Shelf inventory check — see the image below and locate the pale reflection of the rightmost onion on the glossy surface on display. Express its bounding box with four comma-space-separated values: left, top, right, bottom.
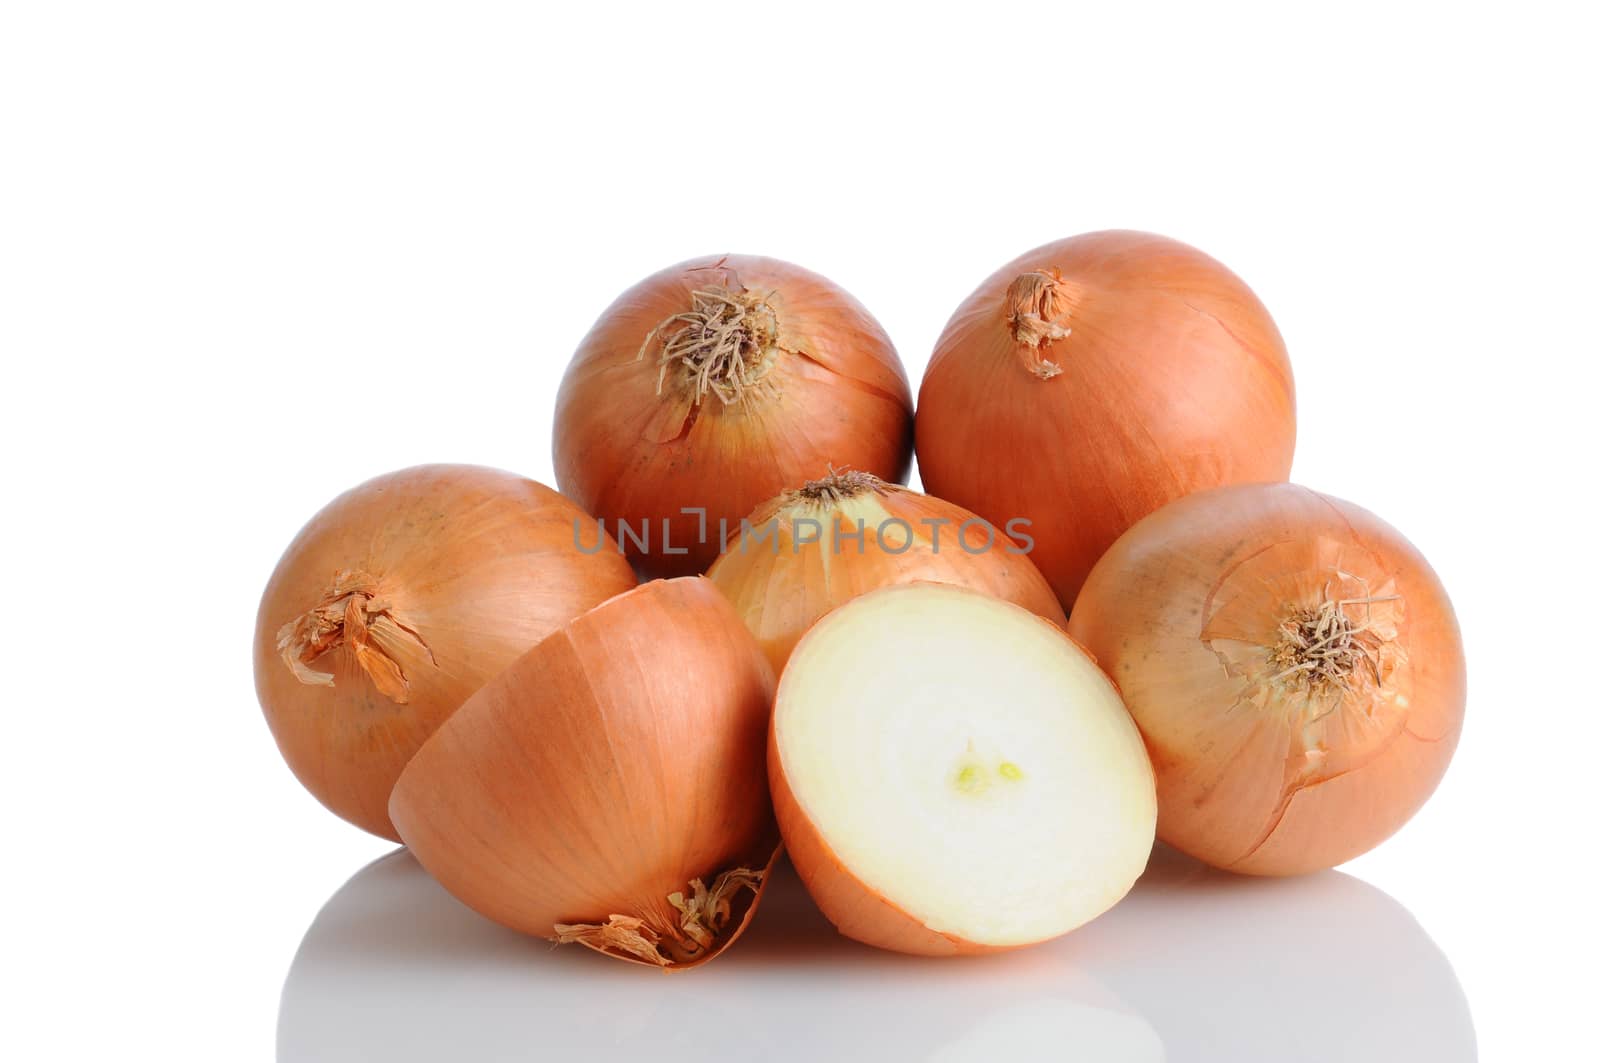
1070, 845, 1477, 1063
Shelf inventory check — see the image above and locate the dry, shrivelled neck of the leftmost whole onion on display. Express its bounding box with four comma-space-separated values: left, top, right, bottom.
278, 570, 432, 704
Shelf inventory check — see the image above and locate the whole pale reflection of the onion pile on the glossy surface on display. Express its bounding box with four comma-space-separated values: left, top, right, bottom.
278, 848, 1477, 1063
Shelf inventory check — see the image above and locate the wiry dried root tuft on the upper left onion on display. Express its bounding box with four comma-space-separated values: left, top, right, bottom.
637, 288, 781, 405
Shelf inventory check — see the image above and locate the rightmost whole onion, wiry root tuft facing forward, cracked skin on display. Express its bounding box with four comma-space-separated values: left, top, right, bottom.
1067, 483, 1466, 874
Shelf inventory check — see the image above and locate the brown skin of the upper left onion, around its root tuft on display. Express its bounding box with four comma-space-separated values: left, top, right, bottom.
554, 255, 912, 576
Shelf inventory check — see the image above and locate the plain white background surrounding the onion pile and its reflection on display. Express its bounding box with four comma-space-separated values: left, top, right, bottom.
0, 2, 1600, 1060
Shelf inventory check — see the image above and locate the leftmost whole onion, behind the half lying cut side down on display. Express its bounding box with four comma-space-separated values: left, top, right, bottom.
254, 464, 635, 840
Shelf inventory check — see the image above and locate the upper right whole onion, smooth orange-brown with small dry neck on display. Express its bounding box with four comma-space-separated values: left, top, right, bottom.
917, 231, 1294, 613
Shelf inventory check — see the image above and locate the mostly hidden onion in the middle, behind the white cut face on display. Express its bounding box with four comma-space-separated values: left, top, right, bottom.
707, 472, 1067, 672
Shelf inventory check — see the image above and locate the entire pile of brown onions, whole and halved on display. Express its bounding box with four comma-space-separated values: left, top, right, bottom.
254, 232, 1466, 970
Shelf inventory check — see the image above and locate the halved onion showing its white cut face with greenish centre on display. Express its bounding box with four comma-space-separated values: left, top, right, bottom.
768, 584, 1155, 956
